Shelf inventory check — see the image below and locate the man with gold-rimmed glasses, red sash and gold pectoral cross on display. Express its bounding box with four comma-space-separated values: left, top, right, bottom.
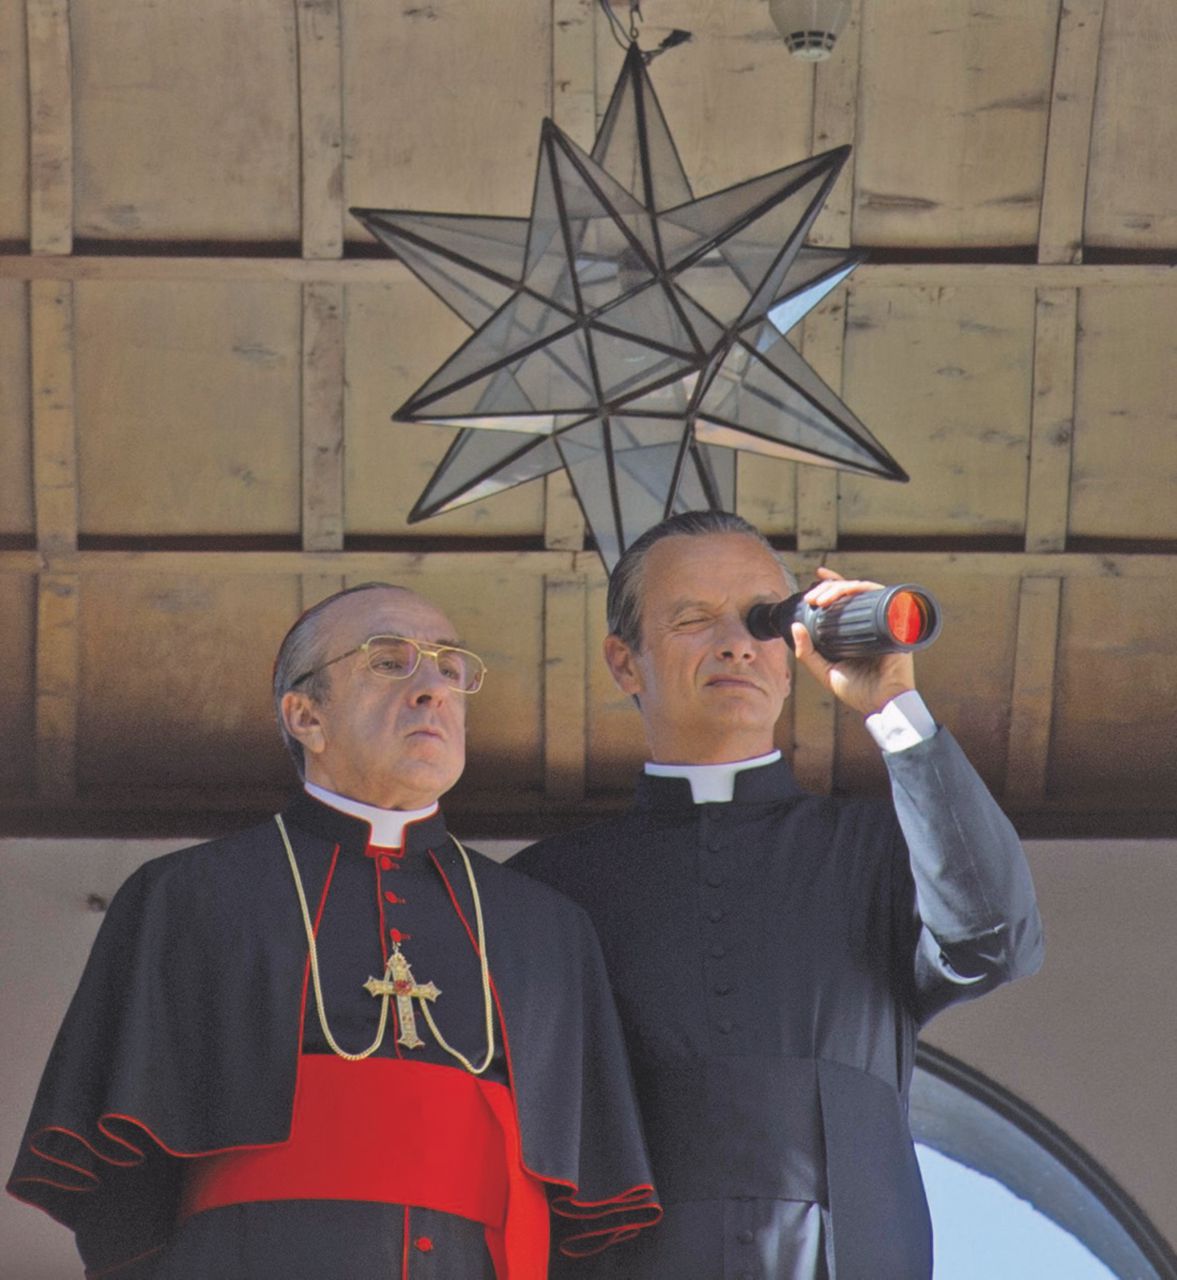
9, 584, 660, 1280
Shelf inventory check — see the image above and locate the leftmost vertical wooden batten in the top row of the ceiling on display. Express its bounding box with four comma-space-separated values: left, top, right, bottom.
24, 0, 73, 253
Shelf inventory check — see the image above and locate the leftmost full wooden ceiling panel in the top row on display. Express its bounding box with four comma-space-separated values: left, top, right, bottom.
70, 0, 299, 244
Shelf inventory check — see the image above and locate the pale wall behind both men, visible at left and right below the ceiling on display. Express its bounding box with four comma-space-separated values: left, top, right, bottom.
0, 840, 1177, 1280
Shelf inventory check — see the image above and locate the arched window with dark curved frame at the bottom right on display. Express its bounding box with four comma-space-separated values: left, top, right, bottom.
911, 1044, 1177, 1280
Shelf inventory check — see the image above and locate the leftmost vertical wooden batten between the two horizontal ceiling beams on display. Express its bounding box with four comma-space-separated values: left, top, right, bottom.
29, 280, 78, 554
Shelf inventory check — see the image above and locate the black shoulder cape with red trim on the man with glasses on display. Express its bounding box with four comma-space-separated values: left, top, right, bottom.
8, 795, 659, 1270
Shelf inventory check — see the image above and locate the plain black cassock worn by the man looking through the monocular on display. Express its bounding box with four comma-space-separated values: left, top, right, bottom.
512, 728, 1043, 1280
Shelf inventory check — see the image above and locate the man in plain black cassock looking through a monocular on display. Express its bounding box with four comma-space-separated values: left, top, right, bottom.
514, 512, 1043, 1280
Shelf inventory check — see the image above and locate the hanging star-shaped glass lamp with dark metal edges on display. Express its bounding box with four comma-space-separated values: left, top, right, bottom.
352, 42, 907, 568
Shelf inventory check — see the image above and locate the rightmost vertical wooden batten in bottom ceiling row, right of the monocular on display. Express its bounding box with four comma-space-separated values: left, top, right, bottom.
1004, 577, 1062, 808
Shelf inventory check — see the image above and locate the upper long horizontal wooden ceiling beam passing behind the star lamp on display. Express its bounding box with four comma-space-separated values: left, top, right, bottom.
0, 251, 1177, 289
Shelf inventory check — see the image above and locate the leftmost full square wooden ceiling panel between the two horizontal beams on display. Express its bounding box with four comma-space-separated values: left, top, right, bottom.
74, 280, 302, 536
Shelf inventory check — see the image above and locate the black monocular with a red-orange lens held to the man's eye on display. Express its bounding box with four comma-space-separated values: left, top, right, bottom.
745, 584, 940, 662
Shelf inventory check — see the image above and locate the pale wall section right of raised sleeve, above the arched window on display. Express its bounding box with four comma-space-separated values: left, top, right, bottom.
925, 840, 1177, 1245
